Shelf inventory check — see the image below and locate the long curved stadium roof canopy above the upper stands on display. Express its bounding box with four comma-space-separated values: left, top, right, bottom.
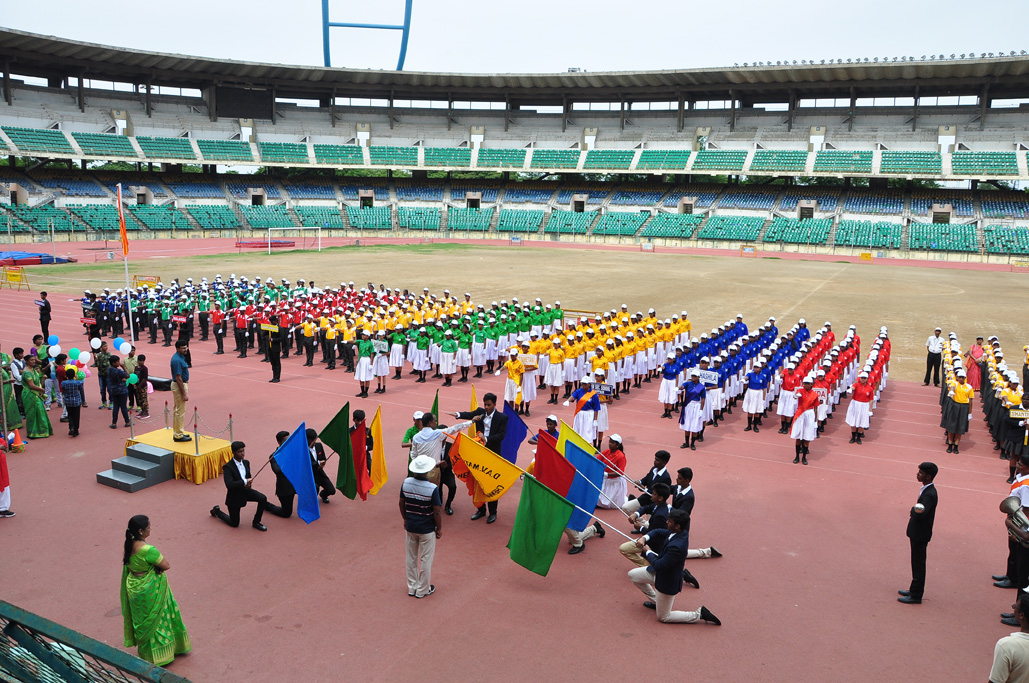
0, 28, 1029, 105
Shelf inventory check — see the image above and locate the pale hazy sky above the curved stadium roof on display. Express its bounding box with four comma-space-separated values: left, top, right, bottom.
0, 0, 1029, 73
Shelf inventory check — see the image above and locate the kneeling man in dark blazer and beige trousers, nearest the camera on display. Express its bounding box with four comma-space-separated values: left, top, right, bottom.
629, 510, 721, 625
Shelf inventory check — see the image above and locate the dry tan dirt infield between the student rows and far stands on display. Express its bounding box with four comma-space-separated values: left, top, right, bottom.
22, 244, 1029, 381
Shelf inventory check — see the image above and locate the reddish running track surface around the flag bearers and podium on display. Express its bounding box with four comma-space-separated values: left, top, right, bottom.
0, 291, 1013, 683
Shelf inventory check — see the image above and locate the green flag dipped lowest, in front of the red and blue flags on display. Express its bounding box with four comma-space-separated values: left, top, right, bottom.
507, 474, 575, 576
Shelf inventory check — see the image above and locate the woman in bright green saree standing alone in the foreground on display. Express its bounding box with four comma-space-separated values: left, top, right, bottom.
121, 514, 192, 667
